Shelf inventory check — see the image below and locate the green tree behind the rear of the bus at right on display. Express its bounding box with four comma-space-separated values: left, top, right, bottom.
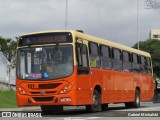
133, 39, 160, 76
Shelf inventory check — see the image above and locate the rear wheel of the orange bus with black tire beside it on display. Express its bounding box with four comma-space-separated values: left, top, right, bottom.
125, 89, 140, 108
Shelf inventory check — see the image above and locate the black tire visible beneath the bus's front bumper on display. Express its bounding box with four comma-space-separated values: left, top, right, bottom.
41, 105, 63, 114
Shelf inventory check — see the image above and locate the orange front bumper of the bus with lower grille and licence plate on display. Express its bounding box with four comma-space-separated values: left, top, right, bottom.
16, 91, 76, 106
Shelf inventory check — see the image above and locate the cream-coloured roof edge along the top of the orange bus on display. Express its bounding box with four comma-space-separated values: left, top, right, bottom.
21, 30, 150, 57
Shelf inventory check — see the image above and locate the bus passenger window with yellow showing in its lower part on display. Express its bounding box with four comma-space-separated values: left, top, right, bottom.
89, 42, 100, 68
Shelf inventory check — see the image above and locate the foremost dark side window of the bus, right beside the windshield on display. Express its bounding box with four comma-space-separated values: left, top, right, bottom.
76, 43, 89, 74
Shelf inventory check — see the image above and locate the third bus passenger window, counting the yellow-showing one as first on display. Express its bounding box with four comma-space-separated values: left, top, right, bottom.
112, 48, 122, 71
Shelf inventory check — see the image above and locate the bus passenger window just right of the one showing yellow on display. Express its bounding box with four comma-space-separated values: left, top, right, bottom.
100, 45, 112, 69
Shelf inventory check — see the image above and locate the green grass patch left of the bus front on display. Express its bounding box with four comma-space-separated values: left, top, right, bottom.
0, 90, 17, 108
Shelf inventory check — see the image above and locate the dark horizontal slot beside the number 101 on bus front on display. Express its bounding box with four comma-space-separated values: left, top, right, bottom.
39, 83, 62, 89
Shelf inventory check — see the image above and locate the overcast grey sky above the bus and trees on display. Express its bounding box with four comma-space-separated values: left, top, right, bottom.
0, 0, 160, 46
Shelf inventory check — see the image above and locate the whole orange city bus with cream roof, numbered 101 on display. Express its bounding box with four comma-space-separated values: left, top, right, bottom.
16, 30, 154, 112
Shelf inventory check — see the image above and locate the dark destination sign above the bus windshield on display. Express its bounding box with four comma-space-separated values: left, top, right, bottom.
18, 32, 72, 46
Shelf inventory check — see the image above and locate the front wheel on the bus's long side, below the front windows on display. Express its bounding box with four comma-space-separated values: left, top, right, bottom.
86, 90, 102, 112
